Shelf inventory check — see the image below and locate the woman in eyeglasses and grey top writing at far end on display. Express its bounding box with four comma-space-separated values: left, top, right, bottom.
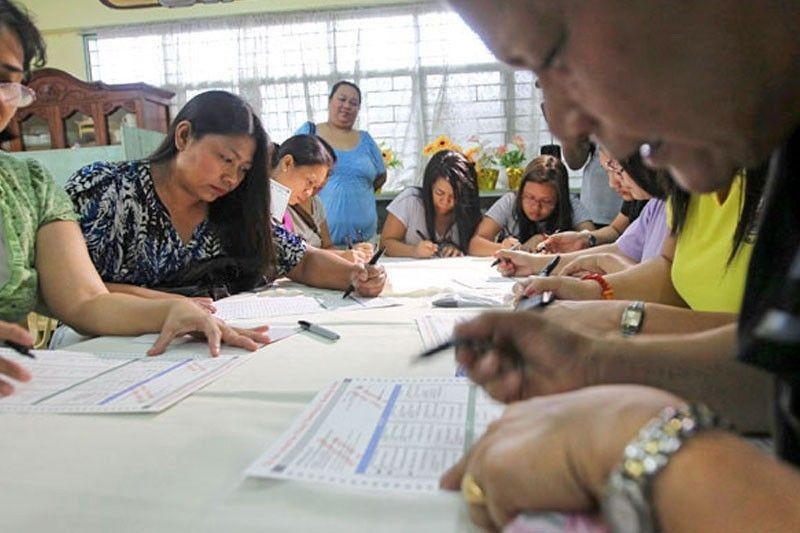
469, 155, 594, 256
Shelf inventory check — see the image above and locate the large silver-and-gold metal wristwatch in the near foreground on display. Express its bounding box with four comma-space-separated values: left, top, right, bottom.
601, 404, 722, 533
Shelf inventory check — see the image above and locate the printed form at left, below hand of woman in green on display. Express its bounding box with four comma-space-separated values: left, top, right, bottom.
0, 349, 246, 413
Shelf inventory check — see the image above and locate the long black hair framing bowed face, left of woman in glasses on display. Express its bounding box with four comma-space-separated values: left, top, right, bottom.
422, 150, 481, 253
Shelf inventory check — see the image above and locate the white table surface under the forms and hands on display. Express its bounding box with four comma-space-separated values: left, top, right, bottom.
0, 258, 516, 532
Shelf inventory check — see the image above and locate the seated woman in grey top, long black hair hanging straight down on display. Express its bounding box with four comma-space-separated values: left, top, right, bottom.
381, 150, 481, 259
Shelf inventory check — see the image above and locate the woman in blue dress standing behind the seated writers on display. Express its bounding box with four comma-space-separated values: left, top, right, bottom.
296, 81, 386, 246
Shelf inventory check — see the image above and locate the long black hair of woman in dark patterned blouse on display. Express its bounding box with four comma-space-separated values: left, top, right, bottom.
148, 91, 275, 272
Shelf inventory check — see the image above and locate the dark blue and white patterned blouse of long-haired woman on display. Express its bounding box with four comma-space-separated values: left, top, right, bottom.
65, 161, 306, 287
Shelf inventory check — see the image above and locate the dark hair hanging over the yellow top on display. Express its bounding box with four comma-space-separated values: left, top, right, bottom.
669, 162, 769, 265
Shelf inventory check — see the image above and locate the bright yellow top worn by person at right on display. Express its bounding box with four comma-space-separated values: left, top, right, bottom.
667, 174, 753, 313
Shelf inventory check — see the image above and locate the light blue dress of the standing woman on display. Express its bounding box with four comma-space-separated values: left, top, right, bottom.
295, 122, 386, 245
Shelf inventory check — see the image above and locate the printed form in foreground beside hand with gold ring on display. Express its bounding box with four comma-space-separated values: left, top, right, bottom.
247, 378, 504, 492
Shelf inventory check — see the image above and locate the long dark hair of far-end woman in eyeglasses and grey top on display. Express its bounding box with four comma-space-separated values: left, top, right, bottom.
514, 155, 573, 237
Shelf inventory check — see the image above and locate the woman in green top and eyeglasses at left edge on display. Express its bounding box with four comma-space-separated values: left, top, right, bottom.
0, 0, 269, 396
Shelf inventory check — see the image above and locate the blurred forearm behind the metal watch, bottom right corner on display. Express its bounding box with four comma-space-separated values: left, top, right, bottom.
652, 431, 800, 533
